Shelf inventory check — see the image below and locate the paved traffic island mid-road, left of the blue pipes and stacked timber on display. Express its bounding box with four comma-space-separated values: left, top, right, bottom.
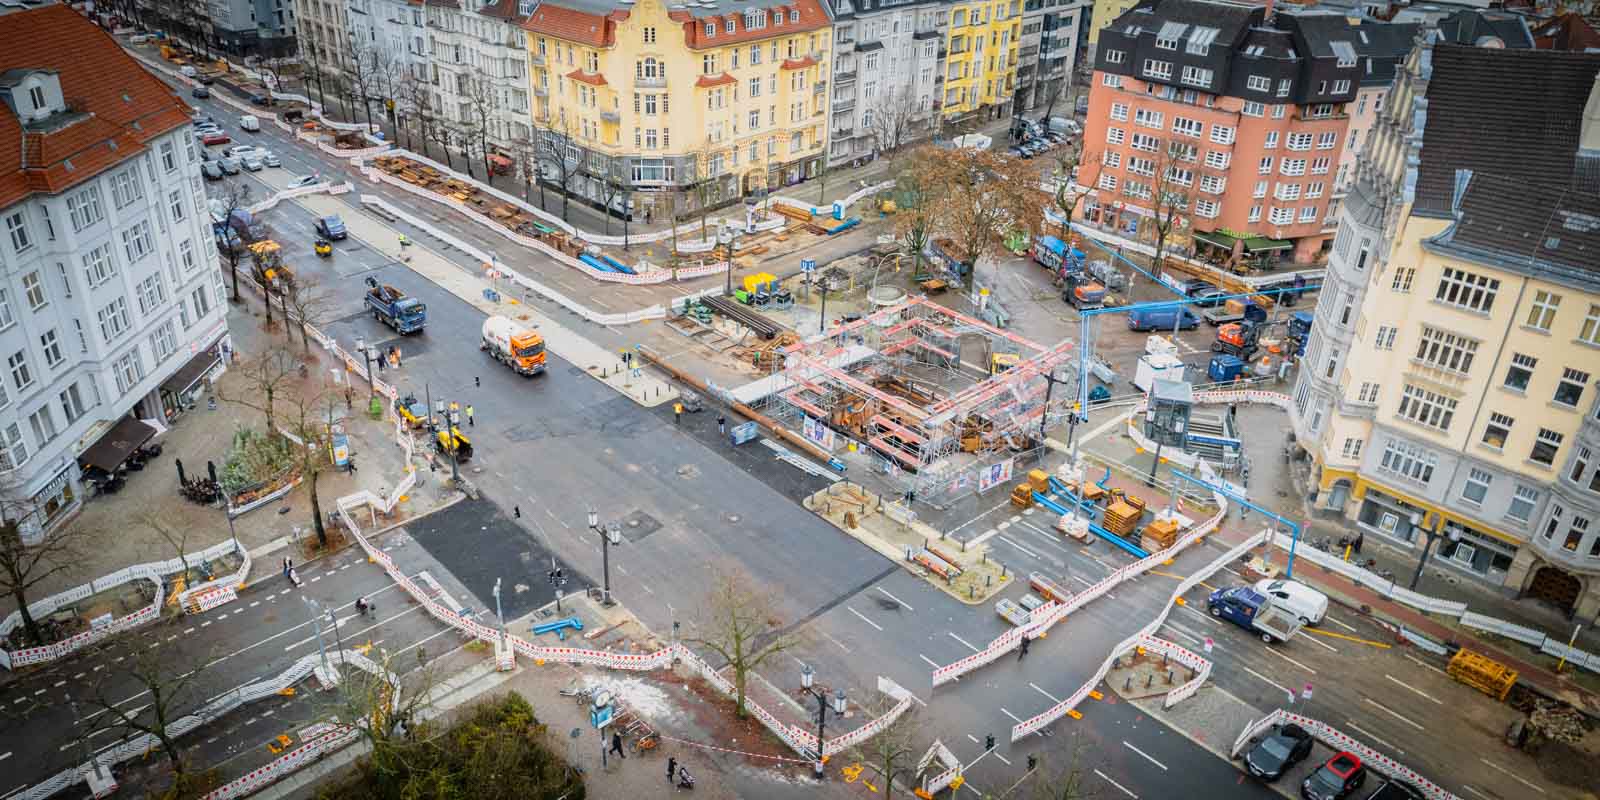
802, 482, 1014, 605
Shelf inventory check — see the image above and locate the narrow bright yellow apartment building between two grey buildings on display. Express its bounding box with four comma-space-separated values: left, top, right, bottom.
941, 0, 1022, 122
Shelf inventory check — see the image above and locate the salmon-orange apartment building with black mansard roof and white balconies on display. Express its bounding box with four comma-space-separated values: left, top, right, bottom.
1078, 0, 1414, 264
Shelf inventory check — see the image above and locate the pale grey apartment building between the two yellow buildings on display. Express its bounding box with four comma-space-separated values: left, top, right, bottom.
827, 0, 950, 165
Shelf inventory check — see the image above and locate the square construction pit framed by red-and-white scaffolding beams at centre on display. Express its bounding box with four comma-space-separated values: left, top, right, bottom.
731, 298, 1077, 506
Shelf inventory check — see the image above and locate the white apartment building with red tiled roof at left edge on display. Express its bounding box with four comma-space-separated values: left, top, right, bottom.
0, 5, 227, 541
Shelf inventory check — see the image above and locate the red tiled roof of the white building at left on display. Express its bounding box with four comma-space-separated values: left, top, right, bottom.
0, 5, 189, 206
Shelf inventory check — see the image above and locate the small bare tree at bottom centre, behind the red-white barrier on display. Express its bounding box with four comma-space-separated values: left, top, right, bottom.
683, 565, 797, 717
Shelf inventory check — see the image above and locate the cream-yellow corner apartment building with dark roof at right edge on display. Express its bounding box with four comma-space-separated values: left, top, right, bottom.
1293, 39, 1600, 619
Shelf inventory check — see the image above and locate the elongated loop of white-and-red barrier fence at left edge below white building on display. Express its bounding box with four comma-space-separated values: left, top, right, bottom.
0, 539, 250, 669
